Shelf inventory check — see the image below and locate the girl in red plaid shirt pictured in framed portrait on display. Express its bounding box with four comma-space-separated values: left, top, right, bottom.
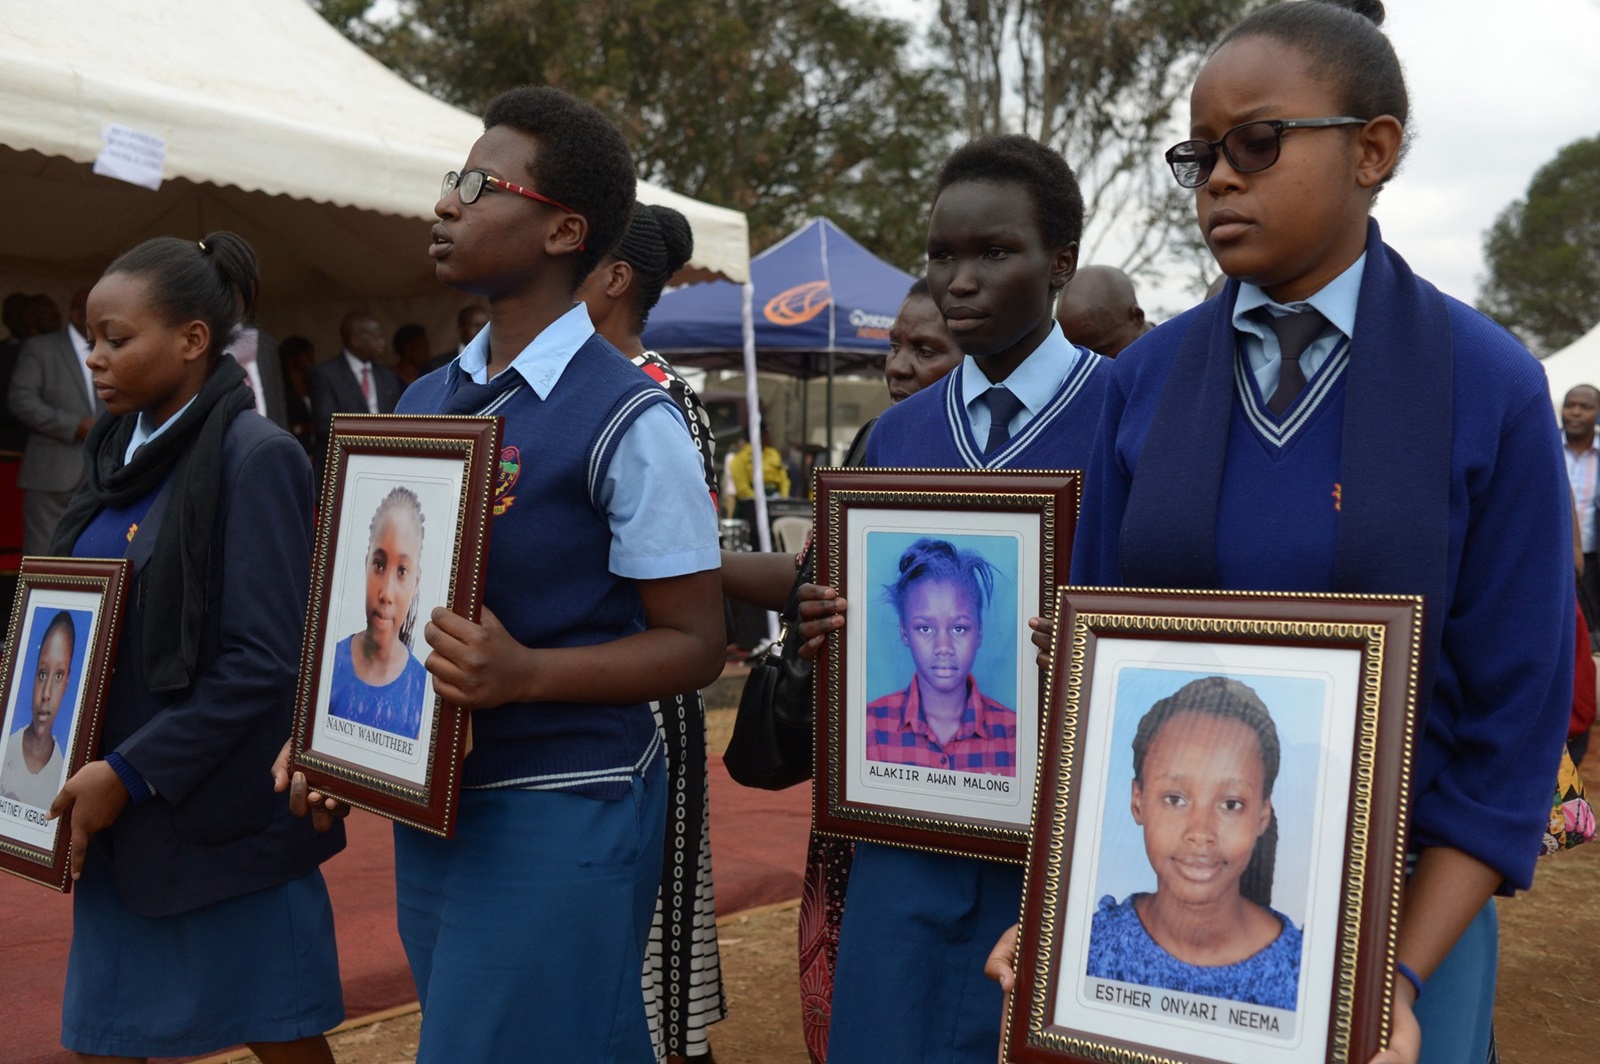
866, 536, 1016, 776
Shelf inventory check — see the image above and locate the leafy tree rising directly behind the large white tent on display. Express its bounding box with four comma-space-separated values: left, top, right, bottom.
312, 0, 957, 267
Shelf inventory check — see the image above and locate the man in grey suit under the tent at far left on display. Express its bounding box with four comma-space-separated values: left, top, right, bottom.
6, 288, 106, 554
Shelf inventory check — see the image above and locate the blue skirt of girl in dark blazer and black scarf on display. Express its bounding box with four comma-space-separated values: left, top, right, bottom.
61, 867, 344, 1056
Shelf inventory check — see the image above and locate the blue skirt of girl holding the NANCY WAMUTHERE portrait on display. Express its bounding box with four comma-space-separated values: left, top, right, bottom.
395, 760, 667, 1064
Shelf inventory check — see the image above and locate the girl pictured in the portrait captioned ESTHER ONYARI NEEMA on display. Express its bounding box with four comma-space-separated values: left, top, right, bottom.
1088, 677, 1301, 1010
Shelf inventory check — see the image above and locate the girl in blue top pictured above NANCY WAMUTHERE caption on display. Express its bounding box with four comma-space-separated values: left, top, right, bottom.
328, 488, 427, 739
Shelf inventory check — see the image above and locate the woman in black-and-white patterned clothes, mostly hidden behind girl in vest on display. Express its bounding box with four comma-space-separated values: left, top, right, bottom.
578, 203, 728, 1064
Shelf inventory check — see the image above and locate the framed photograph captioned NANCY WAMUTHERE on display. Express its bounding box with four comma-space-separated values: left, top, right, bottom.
291, 414, 509, 837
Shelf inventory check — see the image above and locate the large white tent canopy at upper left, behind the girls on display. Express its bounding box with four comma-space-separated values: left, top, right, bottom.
0, 0, 749, 354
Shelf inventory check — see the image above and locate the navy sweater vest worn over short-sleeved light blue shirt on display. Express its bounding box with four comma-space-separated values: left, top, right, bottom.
395, 336, 672, 800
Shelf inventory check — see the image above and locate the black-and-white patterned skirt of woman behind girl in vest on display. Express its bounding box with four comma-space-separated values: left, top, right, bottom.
643, 691, 728, 1061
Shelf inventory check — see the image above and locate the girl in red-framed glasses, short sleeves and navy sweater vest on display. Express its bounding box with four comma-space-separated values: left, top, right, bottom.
385, 88, 723, 1064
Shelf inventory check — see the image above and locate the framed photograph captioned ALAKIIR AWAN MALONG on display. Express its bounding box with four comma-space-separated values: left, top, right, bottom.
813, 469, 1082, 862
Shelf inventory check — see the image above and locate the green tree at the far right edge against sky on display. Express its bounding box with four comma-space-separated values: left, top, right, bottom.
1478, 136, 1600, 355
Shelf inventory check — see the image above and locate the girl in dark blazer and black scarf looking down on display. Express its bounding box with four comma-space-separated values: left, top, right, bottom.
51, 232, 344, 1064
